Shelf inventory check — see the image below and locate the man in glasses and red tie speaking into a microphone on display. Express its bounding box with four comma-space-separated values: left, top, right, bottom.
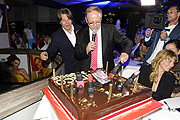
75, 6, 133, 71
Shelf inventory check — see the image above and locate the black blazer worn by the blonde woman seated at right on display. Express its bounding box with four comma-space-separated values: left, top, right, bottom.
138, 65, 176, 100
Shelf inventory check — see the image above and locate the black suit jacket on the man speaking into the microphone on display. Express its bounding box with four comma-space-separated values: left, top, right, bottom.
75, 24, 133, 71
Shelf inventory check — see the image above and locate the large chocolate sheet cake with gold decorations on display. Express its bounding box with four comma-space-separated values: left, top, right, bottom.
49, 72, 152, 120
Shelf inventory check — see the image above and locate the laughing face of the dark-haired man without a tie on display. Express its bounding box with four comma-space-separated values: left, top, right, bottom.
59, 14, 72, 31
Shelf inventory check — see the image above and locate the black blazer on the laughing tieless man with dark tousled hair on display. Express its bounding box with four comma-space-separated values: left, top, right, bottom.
46, 25, 81, 74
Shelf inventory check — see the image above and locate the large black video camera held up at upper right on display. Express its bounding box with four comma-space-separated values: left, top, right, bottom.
145, 13, 166, 30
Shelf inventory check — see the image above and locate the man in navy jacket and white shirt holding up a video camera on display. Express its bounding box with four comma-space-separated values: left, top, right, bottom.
143, 6, 180, 65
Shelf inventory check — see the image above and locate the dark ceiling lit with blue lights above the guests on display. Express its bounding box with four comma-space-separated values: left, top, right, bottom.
6, 0, 180, 12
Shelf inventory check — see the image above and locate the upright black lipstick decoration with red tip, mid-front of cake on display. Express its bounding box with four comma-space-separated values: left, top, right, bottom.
88, 75, 94, 98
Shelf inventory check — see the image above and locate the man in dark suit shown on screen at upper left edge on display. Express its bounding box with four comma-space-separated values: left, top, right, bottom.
0, 5, 7, 32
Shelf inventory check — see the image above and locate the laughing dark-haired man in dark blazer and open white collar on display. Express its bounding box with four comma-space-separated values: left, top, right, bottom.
40, 8, 81, 74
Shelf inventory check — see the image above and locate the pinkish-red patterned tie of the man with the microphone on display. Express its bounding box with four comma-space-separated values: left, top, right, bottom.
91, 34, 98, 70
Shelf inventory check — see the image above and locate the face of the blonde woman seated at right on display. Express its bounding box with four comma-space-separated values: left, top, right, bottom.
159, 57, 175, 72
